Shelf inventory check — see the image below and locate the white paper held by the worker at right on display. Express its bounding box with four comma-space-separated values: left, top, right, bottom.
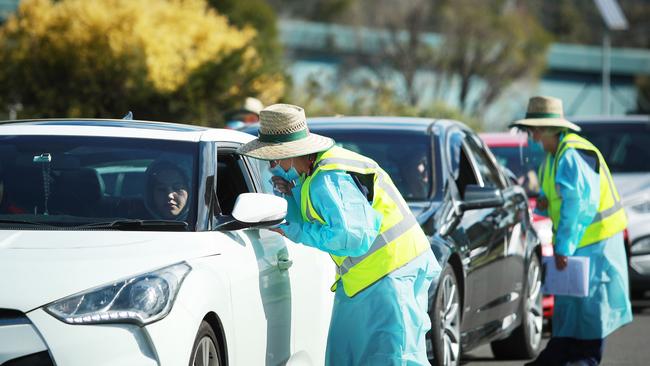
542, 257, 589, 297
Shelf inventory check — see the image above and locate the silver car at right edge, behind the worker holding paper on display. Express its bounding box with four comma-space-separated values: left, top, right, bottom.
570, 116, 650, 297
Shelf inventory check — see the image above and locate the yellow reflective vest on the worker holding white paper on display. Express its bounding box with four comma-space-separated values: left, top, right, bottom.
539, 133, 627, 248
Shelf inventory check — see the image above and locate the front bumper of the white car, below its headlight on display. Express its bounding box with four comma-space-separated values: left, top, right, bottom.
0, 304, 200, 366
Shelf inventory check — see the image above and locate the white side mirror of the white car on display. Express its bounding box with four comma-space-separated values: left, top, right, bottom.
232, 193, 287, 227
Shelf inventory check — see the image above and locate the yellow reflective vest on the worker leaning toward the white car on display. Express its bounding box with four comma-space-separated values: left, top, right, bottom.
300, 147, 430, 297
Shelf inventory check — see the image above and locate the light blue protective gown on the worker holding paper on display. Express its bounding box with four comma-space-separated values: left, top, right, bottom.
542, 148, 632, 339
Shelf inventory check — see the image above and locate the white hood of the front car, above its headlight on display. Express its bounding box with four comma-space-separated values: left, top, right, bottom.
0, 230, 220, 312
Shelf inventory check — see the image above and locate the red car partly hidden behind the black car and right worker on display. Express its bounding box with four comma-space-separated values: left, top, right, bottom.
479, 132, 554, 324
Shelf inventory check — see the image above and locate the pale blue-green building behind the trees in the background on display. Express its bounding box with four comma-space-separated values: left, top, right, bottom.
279, 19, 650, 130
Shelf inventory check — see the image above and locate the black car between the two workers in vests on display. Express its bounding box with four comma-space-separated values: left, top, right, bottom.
243, 117, 542, 365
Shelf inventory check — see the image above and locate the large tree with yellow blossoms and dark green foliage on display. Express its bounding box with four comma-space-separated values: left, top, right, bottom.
0, 0, 284, 125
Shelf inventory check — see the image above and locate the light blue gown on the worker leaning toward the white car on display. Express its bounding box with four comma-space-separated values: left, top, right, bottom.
281, 170, 440, 366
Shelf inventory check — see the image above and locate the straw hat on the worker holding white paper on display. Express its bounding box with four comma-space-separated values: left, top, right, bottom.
510, 96, 580, 131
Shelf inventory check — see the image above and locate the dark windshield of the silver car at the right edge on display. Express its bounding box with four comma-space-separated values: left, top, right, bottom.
580, 122, 650, 173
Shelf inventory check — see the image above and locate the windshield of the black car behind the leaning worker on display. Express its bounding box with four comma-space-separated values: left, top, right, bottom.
311, 127, 433, 201
